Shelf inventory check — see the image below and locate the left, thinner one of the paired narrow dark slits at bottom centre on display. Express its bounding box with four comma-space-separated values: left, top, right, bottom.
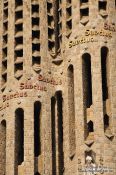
51, 97, 56, 175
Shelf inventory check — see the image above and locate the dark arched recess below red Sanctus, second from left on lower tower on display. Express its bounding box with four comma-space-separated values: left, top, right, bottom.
15, 108, 24, 165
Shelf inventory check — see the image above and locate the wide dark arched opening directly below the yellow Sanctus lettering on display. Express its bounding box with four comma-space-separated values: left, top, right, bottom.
82, 53, 92, 108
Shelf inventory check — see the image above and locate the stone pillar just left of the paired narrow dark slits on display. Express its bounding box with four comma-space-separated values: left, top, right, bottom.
42, 96, 52, 175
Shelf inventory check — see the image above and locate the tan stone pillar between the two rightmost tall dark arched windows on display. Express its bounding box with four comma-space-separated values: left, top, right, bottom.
91, 45, 104, 163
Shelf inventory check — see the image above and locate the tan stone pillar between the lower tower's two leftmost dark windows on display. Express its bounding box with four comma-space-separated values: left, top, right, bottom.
6, 110, 16, 175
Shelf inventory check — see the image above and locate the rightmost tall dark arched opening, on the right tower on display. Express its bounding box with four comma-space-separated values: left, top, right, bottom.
101, 47, 108, 101
